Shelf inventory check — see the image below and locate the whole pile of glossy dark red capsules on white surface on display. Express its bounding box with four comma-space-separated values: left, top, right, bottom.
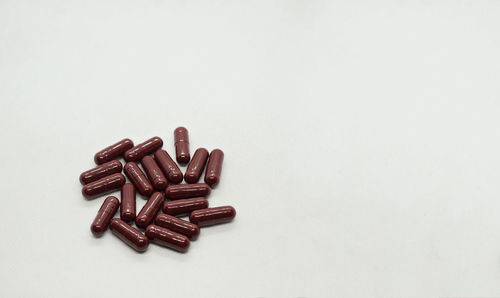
80, 127, 236, 252
